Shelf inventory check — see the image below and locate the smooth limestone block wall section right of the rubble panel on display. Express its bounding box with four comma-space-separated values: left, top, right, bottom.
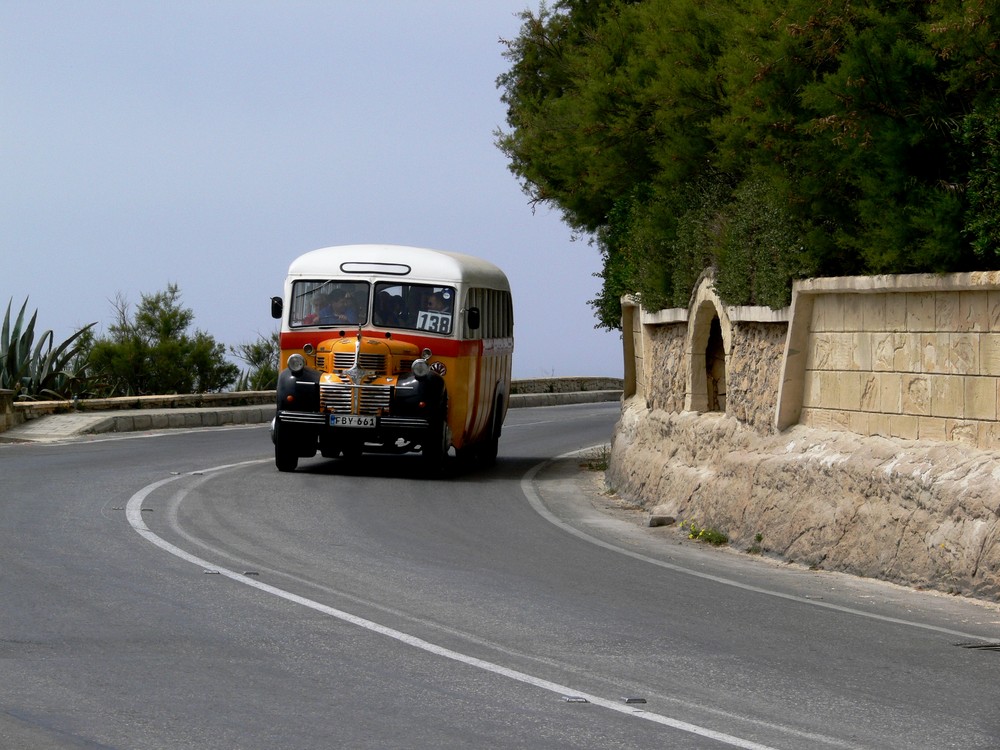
777, 273, 1000, 450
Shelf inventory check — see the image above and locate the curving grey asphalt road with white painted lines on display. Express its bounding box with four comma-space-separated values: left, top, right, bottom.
0, 404, 1000, 750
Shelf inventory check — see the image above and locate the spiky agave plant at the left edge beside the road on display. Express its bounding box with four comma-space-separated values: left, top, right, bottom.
0, 299, 96, 398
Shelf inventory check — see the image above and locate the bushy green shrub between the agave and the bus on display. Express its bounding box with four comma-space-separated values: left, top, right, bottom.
90, 284, 239, 396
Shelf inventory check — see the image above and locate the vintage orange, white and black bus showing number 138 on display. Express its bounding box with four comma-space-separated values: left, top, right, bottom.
271, 245, 514, 471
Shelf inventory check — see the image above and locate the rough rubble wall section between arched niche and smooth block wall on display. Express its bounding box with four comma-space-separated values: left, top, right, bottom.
728, 323, 788, 433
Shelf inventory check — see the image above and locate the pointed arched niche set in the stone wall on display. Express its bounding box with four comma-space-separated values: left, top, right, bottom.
685, 274, 732, 412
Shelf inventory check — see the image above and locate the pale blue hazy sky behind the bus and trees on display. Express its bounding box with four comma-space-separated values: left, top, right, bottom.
0, 0, 622, 378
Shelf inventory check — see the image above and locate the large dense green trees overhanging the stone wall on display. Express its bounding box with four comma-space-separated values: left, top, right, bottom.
497, 0, 1000, 328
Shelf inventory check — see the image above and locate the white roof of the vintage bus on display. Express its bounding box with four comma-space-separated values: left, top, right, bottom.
288, 245, 510, 291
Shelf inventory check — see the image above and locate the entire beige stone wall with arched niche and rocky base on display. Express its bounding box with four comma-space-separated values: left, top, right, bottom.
607, 273, 1000, 598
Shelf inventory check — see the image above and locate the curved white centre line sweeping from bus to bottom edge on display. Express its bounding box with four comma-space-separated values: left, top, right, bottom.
125, 461, 776, 750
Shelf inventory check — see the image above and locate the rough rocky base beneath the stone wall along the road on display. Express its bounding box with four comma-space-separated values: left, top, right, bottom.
607, 399, 1000, 600
